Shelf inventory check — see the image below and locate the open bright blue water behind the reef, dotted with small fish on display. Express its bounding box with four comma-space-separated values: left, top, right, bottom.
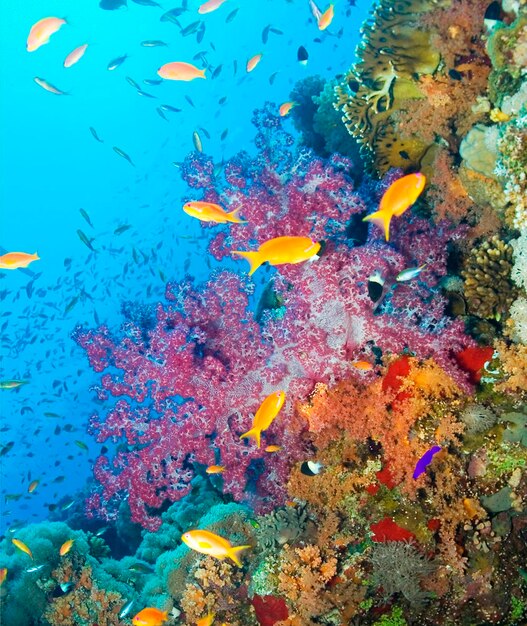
0, 0, 371, 533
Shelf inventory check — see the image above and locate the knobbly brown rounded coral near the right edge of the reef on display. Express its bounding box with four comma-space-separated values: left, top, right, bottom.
461, 235, 516, 321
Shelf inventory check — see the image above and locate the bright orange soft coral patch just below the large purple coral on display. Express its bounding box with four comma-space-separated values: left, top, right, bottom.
295, 359, 461, 490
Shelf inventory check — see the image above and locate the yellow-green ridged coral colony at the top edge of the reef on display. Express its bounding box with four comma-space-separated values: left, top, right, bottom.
335, 0, 449, 174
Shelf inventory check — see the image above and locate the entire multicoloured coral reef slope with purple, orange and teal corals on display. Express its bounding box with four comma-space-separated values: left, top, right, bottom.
4, 0, 527, 626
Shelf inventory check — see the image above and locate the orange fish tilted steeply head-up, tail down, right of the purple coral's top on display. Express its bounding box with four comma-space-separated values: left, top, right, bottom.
363, 172, 426, 241
